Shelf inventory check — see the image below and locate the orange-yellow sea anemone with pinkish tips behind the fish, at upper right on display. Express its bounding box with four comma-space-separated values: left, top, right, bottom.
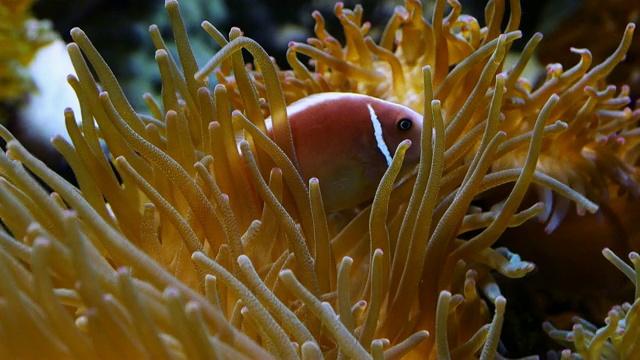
221, 1, 640, 232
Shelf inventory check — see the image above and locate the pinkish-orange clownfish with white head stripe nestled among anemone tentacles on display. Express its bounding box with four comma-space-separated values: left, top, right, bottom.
272, 93, 422, 212
